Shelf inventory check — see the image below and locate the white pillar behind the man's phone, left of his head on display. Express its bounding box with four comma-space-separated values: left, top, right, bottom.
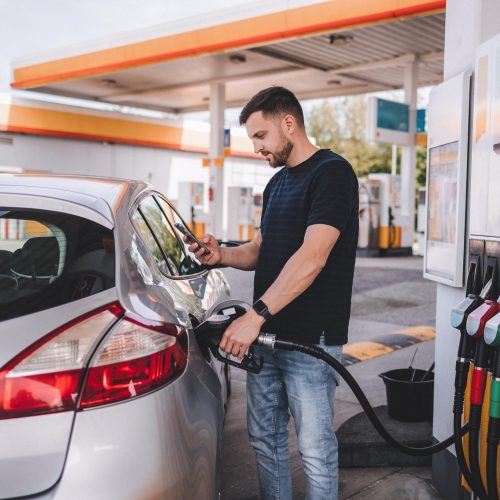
209, 84, 226, 238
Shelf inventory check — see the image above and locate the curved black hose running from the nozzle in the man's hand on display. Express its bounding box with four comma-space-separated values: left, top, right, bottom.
256, 334, 469, 456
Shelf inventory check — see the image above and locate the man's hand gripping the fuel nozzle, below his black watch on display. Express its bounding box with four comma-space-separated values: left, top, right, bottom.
220, 309, 265, 359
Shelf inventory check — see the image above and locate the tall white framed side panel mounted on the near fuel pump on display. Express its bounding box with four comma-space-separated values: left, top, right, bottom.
424, 72, 471, 287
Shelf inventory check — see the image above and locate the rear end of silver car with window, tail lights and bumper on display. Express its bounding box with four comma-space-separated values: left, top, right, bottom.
0, 192, 220, 499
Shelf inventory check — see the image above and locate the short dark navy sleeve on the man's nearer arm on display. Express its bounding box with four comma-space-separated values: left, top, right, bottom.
307, 160, 358, 232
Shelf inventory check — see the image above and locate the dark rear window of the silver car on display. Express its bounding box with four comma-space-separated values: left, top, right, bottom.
0, 207, 115, 321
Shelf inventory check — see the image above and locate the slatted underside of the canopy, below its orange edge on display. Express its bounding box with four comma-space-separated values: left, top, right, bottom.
12, 7, 445, 113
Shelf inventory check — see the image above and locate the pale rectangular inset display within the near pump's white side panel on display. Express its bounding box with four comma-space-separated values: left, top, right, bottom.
426, 141, 459, 280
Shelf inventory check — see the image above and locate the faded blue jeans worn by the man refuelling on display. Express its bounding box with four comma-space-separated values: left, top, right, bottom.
247, 337, 342, 500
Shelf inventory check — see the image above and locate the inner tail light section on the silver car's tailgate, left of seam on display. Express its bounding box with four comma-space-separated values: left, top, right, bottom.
0, 303, 123, 419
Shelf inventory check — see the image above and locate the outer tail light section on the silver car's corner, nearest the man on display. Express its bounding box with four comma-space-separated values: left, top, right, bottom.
80, 317, 187, 408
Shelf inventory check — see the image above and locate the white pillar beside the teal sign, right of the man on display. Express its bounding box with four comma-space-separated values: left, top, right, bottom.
401, 60, 418, 247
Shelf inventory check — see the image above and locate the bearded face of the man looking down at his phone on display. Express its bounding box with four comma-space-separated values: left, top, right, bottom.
245, 111, 293, 168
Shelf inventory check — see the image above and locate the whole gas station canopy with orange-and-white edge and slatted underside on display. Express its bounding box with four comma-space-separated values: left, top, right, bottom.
12, 0, 446, 113
